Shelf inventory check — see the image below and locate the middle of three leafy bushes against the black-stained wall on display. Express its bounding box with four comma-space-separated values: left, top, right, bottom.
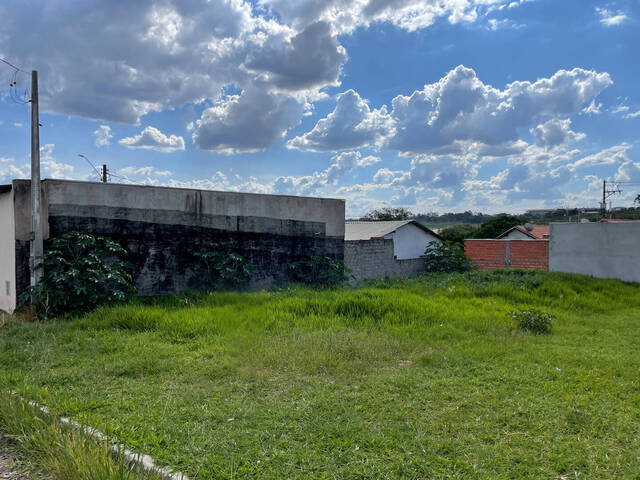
191, 250, 255, 290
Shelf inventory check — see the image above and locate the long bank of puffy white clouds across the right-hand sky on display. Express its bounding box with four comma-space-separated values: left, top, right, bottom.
289, 65, 612, 155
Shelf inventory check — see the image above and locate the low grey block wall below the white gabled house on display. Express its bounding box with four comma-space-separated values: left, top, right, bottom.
344, 239, 424, 280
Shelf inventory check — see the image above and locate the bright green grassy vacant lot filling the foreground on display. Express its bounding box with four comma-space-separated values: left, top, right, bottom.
0, 272, 640, 479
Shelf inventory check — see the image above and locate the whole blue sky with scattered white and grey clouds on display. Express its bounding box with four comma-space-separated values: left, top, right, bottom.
0, 0, 640, 216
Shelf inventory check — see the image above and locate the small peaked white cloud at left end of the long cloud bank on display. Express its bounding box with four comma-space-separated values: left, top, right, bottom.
287, 90, 391, 152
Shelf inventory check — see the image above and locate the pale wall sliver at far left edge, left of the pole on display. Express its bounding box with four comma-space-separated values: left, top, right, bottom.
0, 190, 16, 312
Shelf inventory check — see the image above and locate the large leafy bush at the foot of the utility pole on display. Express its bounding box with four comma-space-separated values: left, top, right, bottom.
20, 232, 134, 319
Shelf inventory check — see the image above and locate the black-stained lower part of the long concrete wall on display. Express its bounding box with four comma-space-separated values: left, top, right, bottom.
45, 205, 344, 295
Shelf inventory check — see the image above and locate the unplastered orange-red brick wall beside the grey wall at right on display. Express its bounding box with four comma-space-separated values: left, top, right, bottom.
464, 240, 549, 270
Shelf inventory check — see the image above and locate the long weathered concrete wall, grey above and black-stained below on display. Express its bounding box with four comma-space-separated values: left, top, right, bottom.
12, 180, 344, 295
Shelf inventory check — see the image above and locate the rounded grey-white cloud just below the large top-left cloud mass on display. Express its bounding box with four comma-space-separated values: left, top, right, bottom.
192, 89, 304, 155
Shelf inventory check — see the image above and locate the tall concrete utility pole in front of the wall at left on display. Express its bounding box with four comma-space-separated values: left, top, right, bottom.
29, 70, 44, 287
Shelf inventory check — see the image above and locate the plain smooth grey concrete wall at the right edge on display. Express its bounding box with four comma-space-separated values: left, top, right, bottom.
549, 222, 640, 282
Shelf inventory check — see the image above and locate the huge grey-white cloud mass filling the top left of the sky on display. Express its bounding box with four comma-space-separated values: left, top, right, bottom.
0, 0, 347, 124
